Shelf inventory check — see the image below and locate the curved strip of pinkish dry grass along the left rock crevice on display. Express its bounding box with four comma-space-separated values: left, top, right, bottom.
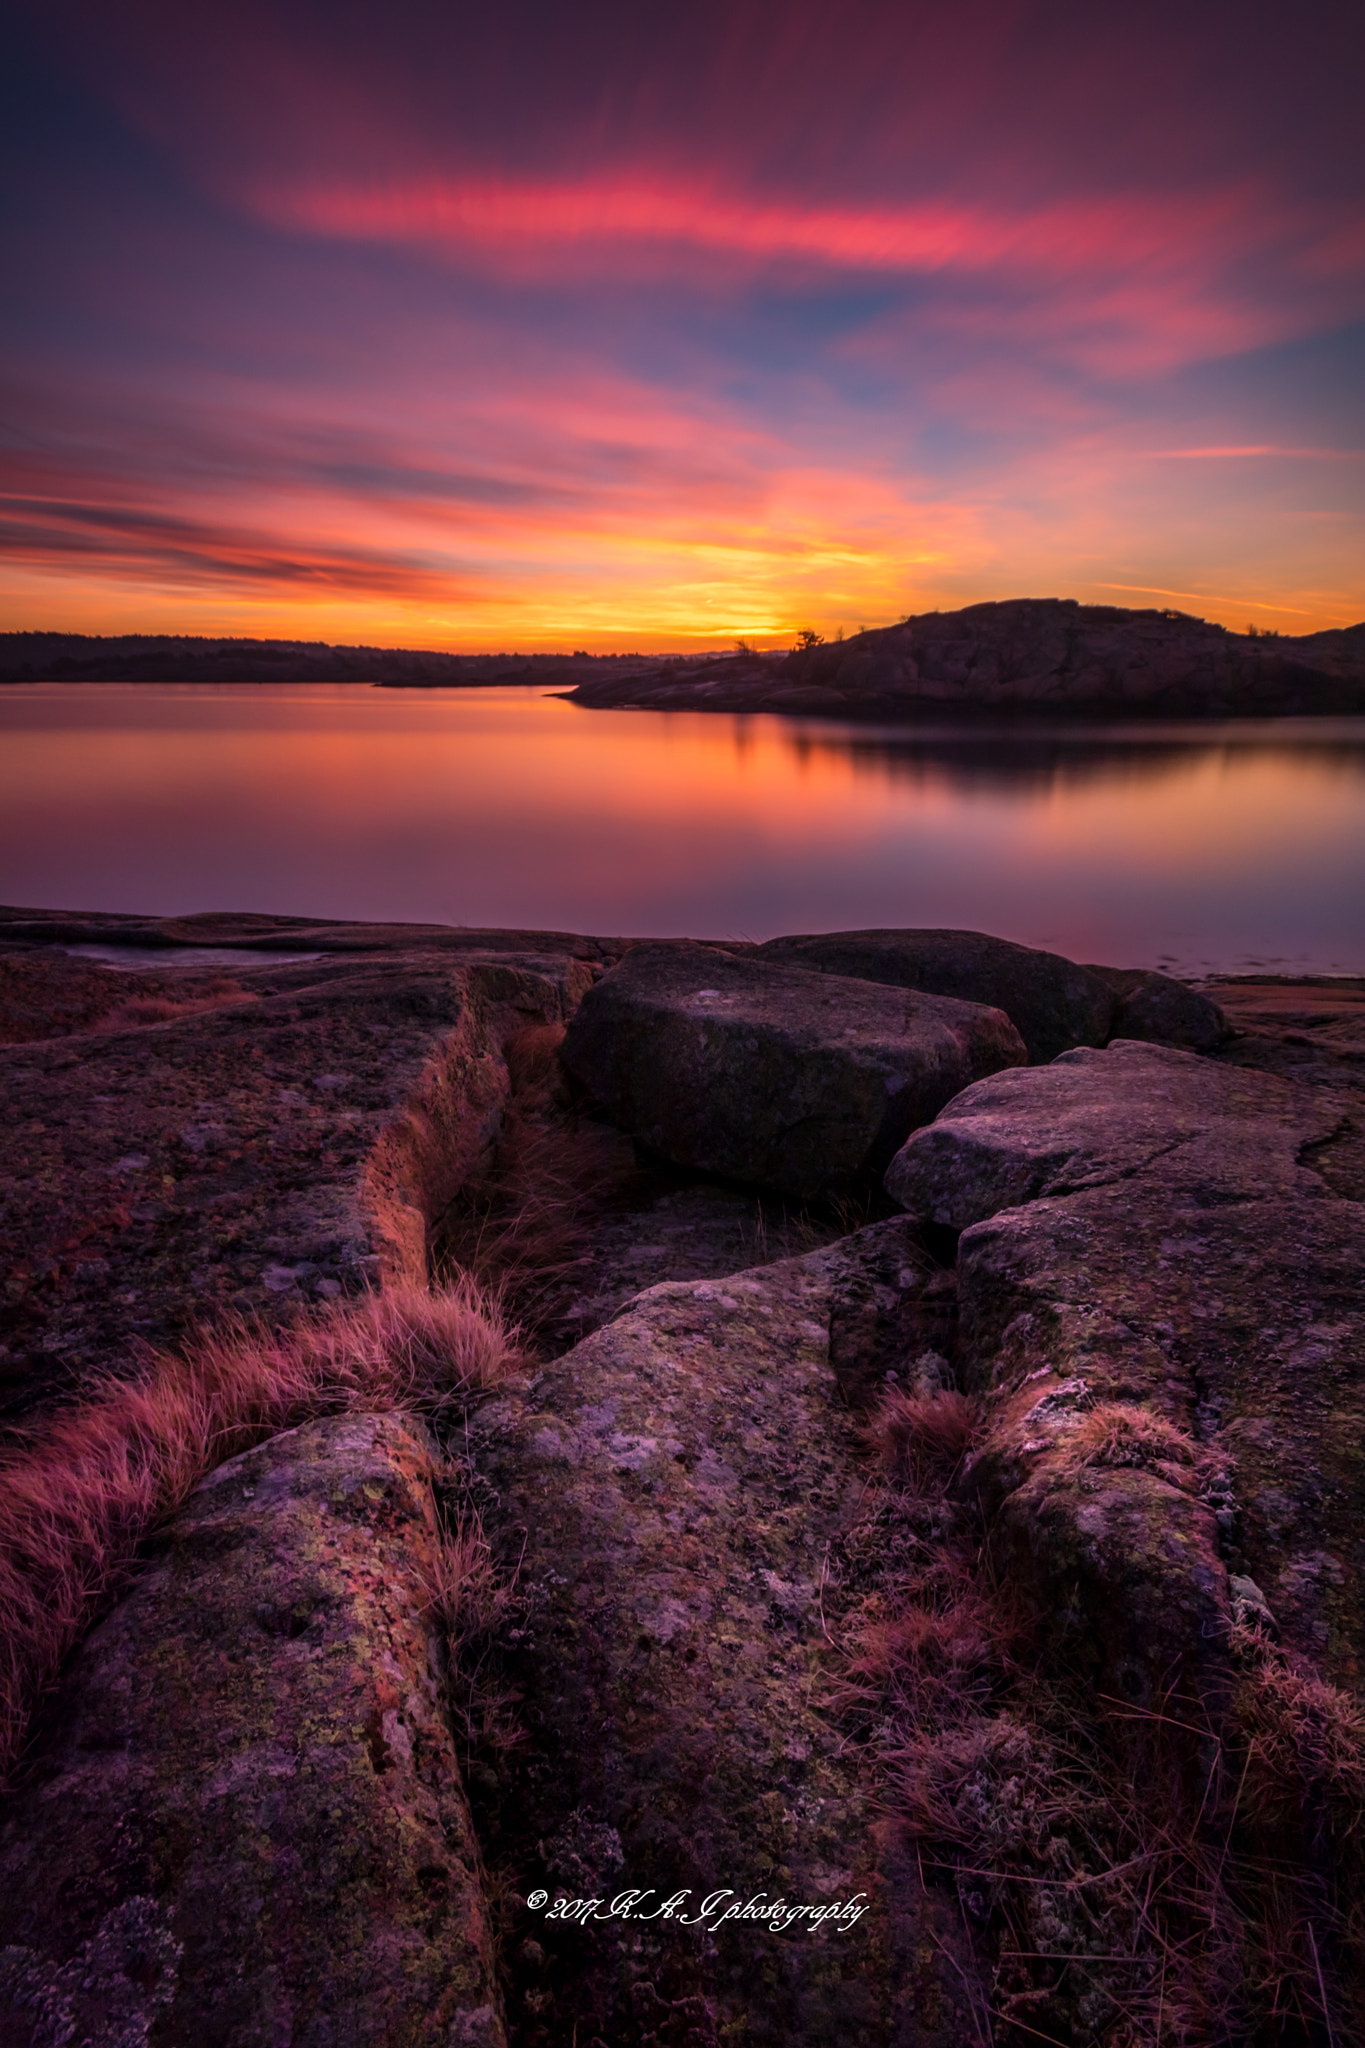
0, 1282, 518, 1772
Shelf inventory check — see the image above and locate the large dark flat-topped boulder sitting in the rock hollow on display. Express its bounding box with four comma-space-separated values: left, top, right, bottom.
563, 942, 1025, 1198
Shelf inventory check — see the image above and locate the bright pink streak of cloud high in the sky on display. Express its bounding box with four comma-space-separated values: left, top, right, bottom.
244, 164, 1365, 377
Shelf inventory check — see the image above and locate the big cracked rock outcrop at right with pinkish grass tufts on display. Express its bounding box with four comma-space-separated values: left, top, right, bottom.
888, 1044, 1365, 1698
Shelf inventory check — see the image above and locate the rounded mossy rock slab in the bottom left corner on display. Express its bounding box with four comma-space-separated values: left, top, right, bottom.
0, 1415, 503, 2048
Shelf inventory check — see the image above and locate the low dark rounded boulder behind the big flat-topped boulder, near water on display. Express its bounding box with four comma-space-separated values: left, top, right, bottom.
757, 930, 1117, 1065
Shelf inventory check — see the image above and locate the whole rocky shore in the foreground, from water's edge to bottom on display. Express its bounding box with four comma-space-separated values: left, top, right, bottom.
0, 911, 1365, 2048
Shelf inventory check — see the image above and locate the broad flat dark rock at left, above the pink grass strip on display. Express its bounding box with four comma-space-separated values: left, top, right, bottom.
0, 915, 593, 1421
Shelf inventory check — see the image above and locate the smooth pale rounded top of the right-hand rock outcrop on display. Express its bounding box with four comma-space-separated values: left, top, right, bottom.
886, 1040, 1338, 1231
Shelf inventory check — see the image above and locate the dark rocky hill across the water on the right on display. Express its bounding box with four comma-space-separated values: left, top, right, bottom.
569, 598, 1365, 719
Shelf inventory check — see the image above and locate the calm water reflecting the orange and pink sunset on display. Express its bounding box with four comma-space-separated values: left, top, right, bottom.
0, 684, 1365, 973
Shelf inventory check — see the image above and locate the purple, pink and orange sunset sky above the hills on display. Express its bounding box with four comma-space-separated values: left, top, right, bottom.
0, 0, 1365, 651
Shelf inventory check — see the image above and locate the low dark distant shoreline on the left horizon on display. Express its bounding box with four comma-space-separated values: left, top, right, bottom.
0, 633, 657, 688
